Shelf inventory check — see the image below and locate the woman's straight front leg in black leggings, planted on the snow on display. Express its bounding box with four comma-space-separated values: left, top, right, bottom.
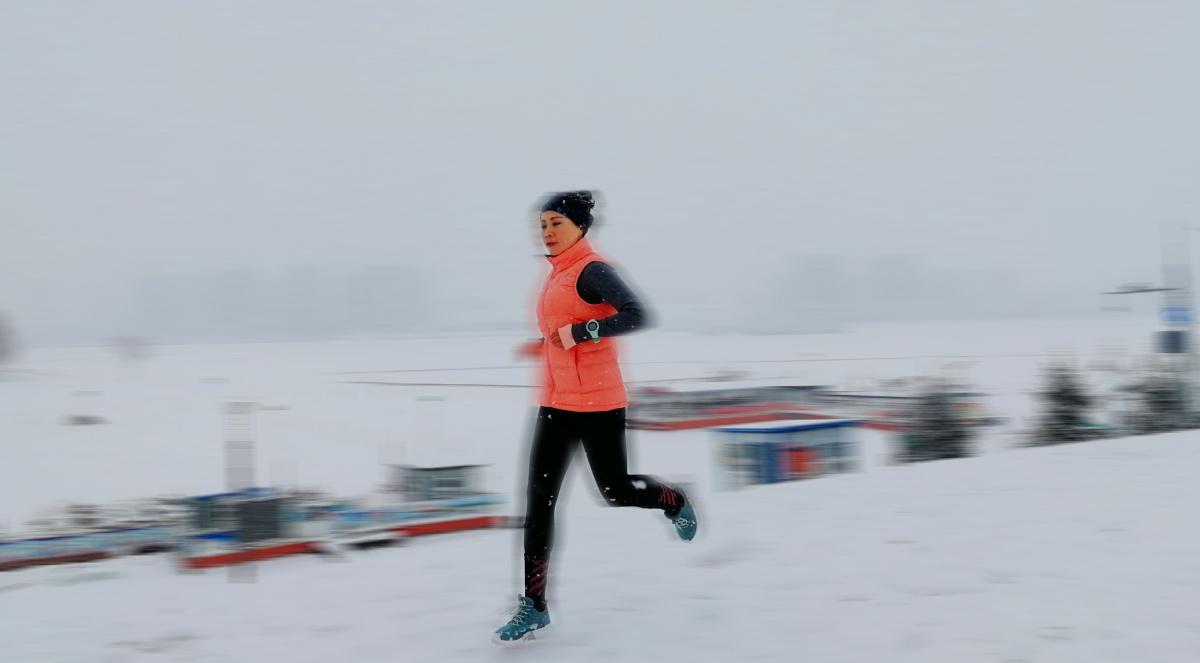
524, 407, 578, 610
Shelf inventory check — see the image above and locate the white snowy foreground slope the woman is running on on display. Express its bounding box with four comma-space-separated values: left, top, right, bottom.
7, 434, 1200, 662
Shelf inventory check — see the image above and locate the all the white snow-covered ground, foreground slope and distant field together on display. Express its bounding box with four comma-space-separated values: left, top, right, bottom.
0, 318, 1200, 663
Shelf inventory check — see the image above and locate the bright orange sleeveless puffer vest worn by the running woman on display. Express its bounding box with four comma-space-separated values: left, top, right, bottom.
538, 239, 628, 412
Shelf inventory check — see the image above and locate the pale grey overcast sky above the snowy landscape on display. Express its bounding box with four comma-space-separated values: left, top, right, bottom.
0, 0, 1200, 340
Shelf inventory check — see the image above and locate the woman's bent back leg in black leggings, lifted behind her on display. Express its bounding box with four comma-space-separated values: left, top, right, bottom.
581, 408, 684, 516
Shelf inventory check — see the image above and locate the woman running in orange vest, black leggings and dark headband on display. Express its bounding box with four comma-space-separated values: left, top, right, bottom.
493, 191, 696, 644
